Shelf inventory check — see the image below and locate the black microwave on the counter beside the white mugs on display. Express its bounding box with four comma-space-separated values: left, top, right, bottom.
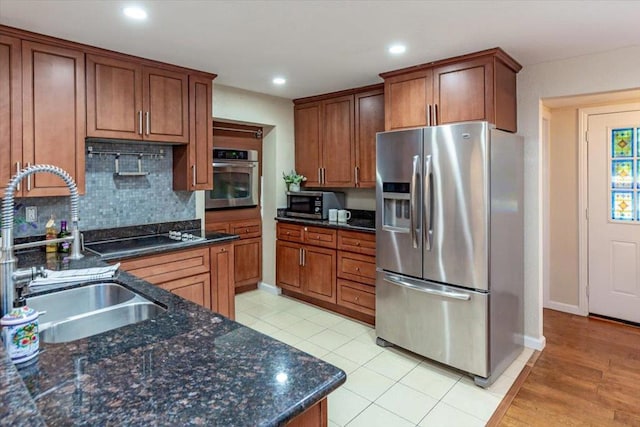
285, 191, 344, 219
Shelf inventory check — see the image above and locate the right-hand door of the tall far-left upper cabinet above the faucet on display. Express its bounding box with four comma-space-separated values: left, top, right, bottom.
16, 40, 86, 197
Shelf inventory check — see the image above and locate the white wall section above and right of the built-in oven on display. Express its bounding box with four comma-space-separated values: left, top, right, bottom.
210, 81, 295, 285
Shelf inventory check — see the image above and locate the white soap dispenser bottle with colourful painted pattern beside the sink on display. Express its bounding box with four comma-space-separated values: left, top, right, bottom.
0, 287, 40, 364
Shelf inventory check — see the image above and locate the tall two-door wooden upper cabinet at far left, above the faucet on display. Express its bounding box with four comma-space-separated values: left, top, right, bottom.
0, 34, 85, 197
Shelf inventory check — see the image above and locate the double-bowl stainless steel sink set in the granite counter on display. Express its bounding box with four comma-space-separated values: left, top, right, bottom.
27, 282, 166, 343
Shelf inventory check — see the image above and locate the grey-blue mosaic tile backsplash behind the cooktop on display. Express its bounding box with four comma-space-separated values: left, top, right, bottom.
3, 141, 196, 237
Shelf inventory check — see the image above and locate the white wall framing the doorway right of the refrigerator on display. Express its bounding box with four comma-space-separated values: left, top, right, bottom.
518, 46, 640, 348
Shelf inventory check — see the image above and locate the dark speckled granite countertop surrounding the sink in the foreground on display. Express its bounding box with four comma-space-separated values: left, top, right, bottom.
0, 232, 346, 426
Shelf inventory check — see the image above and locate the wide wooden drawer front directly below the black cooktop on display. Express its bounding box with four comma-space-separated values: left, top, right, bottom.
120, 248, 209, 285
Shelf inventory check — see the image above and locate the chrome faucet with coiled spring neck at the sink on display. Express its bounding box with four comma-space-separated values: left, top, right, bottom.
0, 165, 83, 316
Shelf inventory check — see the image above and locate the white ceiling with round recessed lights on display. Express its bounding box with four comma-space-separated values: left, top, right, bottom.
0, 0, 640, 98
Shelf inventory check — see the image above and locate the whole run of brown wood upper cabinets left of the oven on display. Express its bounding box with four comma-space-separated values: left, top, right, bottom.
0, 25, 216, 201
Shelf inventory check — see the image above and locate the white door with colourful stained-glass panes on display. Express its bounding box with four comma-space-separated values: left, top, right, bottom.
588, 111, 640, 323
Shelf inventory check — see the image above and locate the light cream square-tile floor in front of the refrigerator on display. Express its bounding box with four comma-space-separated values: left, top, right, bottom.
236, 290, 533, 427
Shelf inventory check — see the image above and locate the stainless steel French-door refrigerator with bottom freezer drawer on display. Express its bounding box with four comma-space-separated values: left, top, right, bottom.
376, 122, 524, 387
